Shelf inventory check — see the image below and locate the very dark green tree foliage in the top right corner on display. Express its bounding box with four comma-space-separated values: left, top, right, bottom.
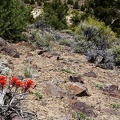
83, 0, 120, 36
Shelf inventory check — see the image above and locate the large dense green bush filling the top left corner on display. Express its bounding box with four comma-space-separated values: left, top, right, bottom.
0, 0, 31, 40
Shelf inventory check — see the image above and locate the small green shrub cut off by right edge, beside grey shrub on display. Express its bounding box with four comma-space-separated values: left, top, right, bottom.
113, 45, 120, 66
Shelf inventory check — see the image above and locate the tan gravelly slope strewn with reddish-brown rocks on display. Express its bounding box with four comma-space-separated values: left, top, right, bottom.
0, 42, 120, 120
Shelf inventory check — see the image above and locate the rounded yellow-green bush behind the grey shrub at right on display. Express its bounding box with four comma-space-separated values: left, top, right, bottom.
76, 17, 116, 47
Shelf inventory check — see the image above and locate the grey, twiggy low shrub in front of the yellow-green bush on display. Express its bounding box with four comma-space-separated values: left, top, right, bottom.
74, 35, 115, 69
